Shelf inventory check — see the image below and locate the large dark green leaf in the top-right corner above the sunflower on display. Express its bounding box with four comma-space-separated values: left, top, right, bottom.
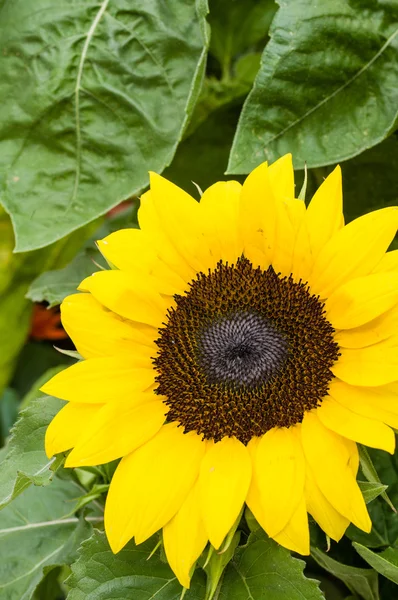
228, 0, 398, 173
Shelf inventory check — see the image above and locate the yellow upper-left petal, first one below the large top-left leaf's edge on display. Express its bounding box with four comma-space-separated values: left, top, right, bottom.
97, 229, 186, 295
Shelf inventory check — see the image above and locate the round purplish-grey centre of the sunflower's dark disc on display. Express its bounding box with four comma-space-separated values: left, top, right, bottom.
198, 312, 288, 386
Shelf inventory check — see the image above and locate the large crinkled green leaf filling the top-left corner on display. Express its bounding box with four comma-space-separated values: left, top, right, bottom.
0, 0, 207, 251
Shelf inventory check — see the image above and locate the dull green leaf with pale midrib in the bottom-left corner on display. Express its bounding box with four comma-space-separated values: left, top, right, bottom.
0, 479, 98, 600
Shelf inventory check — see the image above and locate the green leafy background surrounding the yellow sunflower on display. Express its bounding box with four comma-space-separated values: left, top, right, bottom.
0, 0, 398, 600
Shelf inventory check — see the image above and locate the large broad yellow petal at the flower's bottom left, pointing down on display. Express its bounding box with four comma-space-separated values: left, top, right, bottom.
105, 423, 206, 552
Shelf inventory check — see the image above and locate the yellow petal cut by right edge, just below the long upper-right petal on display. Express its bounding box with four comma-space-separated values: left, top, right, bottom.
325, 272, 398, 329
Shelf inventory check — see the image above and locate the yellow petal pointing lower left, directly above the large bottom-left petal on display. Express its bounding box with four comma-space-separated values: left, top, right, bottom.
65, 393, 167, 467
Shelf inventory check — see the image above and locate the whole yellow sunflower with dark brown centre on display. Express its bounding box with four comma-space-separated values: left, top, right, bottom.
43, 155, 398, 587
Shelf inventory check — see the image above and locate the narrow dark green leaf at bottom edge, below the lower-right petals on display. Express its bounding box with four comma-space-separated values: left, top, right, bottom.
311, 548, 380, 600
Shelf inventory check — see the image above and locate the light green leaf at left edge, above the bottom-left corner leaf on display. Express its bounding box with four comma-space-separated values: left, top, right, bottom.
0, 396, 64, 508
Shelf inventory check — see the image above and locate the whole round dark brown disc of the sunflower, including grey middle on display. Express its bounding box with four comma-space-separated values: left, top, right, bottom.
154, 258, 339, 444
